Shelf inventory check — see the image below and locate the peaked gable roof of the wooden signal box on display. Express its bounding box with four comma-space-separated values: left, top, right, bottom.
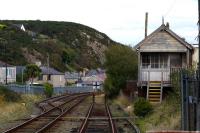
135, 24, 193, 52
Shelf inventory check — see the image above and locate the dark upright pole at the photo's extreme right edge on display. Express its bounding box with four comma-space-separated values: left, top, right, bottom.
196, 0, 200, 131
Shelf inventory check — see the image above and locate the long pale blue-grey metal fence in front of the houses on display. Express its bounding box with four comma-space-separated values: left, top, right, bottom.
3, 84, 102, 94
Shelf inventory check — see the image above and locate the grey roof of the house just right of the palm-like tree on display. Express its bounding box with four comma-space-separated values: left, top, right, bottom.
40, 66, 64, 75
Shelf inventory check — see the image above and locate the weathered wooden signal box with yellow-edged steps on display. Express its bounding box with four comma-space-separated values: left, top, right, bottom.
135, 24, 193, 102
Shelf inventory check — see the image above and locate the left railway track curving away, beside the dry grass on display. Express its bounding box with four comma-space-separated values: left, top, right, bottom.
4, 93, 91, 133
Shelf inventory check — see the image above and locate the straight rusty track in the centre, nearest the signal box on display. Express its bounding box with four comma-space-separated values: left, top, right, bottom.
77, 95, 117, 133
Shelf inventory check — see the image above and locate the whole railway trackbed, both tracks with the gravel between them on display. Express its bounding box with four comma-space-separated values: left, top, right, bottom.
4, 93, 140, 133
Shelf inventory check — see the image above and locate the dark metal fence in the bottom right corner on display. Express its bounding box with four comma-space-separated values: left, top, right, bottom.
181, 71, 200, 131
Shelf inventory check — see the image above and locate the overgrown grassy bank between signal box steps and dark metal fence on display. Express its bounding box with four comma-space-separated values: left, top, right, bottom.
136, 70, 184, 133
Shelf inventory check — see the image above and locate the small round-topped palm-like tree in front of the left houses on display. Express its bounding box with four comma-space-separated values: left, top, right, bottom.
25, 64, 41, 84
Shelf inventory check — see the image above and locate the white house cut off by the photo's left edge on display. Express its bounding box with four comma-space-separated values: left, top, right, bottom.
0, 61, 16, 84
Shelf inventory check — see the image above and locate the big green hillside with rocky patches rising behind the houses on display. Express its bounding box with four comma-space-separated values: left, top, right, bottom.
0, 20, 119, 71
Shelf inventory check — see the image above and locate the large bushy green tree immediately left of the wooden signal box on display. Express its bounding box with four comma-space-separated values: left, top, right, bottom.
104, 45, 137, 97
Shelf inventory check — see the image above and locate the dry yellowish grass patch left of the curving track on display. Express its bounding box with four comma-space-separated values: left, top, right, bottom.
0, 94, 44, 132
